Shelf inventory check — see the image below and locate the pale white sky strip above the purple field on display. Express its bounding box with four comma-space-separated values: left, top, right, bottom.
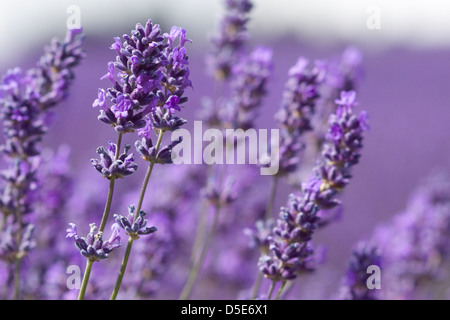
0, 0, 450, 65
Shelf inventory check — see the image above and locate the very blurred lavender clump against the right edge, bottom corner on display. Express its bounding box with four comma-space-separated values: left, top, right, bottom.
370, 172, 450, 300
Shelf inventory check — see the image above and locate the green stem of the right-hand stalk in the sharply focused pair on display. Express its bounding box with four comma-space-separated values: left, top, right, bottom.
110, 130, 164, 300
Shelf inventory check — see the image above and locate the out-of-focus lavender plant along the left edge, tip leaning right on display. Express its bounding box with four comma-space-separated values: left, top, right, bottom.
0, 29, 84, 299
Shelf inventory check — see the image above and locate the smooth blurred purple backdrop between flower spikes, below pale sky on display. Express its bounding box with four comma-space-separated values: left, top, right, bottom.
0, 2, 450, 298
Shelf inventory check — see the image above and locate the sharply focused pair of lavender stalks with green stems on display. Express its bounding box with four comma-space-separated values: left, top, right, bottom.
67, 20, 192, 299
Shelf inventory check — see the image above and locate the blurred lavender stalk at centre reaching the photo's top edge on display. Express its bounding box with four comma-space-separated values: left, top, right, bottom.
180, 0, 273, 299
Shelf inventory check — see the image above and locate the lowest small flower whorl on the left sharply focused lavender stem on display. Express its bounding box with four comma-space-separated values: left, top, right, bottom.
66, 223, 121, 261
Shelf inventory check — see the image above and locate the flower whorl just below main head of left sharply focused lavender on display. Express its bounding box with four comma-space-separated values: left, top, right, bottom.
91, 142, 137, 180
